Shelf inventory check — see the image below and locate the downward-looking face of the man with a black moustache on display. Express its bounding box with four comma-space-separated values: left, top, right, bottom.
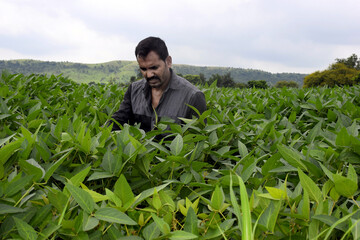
137, 51, 172, 90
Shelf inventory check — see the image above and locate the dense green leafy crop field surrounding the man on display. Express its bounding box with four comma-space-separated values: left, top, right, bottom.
0, 73, 360, 240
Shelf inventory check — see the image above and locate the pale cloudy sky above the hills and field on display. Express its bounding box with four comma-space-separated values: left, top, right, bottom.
0, 0, 360, 73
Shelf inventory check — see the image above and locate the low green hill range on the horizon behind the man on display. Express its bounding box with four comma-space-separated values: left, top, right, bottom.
0, 59, 306, 86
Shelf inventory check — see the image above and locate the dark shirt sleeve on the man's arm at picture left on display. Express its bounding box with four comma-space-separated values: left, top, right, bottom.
109, 85, 134, 131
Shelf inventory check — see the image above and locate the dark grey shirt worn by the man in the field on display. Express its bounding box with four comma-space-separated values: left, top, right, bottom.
112, 70, 206, 131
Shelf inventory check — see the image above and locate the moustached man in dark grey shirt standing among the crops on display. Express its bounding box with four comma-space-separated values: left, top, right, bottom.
112, 37, 206, 132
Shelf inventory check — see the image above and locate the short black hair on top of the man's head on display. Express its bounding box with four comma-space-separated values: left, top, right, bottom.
135, 37, 169, 61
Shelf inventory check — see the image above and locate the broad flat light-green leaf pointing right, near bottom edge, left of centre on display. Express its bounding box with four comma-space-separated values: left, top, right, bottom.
94, 207, 137, 225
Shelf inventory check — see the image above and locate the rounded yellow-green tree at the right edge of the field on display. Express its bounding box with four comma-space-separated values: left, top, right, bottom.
303, 63, 360, 88
